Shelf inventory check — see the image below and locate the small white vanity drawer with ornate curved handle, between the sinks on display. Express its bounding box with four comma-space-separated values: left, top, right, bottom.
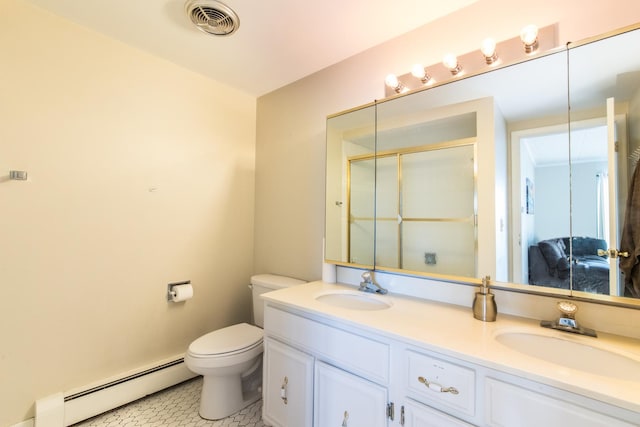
406, 350, 476, 417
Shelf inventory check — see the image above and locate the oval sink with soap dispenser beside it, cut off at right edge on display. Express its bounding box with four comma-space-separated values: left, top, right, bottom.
495, 331, 640, 381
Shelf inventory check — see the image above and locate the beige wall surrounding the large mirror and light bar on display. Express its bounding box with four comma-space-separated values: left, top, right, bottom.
255, 0, 640, 280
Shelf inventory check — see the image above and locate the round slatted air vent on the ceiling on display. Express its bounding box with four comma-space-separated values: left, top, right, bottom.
184, 0, 240, 36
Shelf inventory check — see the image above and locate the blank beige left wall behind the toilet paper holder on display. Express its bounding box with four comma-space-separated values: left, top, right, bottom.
0, 0, 256, 426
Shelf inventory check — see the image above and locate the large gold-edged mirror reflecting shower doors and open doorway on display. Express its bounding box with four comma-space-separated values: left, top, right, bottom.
325, 22, 640, 308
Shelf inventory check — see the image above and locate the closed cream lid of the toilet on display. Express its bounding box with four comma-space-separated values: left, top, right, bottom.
189, 323, 262, 355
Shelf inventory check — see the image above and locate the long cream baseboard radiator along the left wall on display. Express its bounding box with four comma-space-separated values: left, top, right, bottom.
35, 357, 196, 427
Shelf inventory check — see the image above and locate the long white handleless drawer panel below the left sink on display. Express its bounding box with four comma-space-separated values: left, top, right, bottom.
264, 305, 390, 385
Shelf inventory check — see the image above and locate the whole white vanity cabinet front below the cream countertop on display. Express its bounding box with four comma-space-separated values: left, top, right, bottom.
263, 292, 640, 427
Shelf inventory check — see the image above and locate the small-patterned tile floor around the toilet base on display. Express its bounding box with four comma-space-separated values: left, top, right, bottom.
74, 377, 266, 427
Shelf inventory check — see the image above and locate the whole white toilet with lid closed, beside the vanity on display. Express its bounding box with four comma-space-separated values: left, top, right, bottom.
184, 274, 305, 420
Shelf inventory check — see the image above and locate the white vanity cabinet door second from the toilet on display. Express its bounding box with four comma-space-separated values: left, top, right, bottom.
314, 362, 387, 427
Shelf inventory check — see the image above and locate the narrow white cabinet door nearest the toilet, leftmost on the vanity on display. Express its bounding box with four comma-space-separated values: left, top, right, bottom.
262, 339, 313, 427
